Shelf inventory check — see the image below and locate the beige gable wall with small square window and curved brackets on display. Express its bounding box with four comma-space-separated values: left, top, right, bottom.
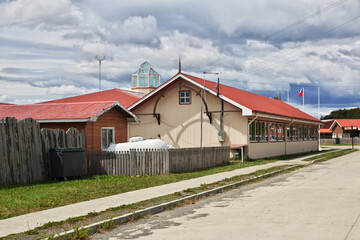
128, 81, 247, 148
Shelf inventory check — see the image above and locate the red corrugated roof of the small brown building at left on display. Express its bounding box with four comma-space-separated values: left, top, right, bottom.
0, 102, 121, 120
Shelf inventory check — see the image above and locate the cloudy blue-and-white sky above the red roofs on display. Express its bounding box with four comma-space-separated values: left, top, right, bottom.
0, 0, 360, 117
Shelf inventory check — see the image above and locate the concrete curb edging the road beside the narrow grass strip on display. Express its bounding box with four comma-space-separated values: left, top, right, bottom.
45, 165, 302, 240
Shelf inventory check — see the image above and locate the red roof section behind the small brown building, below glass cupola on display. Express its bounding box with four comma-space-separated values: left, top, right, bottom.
41, 88, 140, 108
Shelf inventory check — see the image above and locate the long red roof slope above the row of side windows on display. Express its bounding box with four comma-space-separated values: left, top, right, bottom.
181, 73, 321, 122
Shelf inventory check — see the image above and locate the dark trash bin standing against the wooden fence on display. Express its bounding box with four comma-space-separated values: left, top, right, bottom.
50, 148, 85, 178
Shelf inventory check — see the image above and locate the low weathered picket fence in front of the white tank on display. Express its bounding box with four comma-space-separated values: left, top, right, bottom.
90, 147, 230, 176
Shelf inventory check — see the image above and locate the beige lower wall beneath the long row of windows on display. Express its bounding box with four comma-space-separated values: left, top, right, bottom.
248, 140, 318, 159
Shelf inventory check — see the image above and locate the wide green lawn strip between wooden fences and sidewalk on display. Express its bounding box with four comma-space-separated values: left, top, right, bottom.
0, 160, 276, 219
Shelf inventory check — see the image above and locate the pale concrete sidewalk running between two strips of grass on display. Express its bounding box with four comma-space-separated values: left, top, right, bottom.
0, 151, 338, 237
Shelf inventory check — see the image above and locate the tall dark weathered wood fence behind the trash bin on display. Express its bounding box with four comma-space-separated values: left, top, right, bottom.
0, 117, 86, 185
